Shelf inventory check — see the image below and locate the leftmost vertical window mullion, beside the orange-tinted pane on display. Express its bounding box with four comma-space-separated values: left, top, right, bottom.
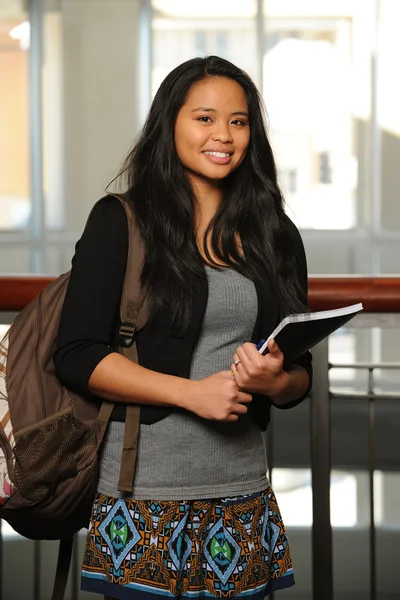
28, 0, 45, 273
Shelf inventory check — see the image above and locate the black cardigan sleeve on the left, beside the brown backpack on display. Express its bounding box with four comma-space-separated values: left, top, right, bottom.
54, 196, 128, 395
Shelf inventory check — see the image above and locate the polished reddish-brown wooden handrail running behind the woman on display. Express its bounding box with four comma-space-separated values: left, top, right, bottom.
0, 275, 400, 313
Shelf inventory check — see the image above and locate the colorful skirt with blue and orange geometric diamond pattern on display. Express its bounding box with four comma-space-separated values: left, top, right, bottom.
82, 488, 294, 600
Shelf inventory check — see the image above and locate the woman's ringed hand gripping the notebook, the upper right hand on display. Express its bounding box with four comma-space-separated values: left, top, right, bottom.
231, 339, 290, 398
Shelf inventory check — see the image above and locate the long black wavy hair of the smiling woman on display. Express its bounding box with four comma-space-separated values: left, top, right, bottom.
111, 56, 305, 330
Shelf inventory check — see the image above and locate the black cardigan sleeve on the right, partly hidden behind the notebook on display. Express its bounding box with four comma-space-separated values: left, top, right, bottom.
273, 218, 313, 409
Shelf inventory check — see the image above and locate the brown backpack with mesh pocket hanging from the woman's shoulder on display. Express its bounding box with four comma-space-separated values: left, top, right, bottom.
0, 196, 147, 600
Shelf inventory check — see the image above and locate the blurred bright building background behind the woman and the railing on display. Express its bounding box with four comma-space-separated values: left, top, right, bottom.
0, 0, 400, 600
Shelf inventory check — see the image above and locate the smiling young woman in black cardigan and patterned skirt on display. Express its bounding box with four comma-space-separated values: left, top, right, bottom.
55, 56, 312, 600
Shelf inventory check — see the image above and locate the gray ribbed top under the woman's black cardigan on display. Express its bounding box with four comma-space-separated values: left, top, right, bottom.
98, 267, 268, 500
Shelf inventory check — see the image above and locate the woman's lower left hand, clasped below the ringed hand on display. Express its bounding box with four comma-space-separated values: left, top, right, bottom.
184, 371, 252, 421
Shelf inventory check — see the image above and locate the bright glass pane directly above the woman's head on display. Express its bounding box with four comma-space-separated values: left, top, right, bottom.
152, 0, 257, 95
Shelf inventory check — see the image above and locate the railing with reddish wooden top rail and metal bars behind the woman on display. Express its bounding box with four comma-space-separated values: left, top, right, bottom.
0, 276, 400, 600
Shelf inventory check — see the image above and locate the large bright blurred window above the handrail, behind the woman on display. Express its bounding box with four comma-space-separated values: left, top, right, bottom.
0, 0, 400, 274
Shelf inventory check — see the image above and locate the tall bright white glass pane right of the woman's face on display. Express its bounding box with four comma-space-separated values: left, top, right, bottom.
263, 0, 371, 230
